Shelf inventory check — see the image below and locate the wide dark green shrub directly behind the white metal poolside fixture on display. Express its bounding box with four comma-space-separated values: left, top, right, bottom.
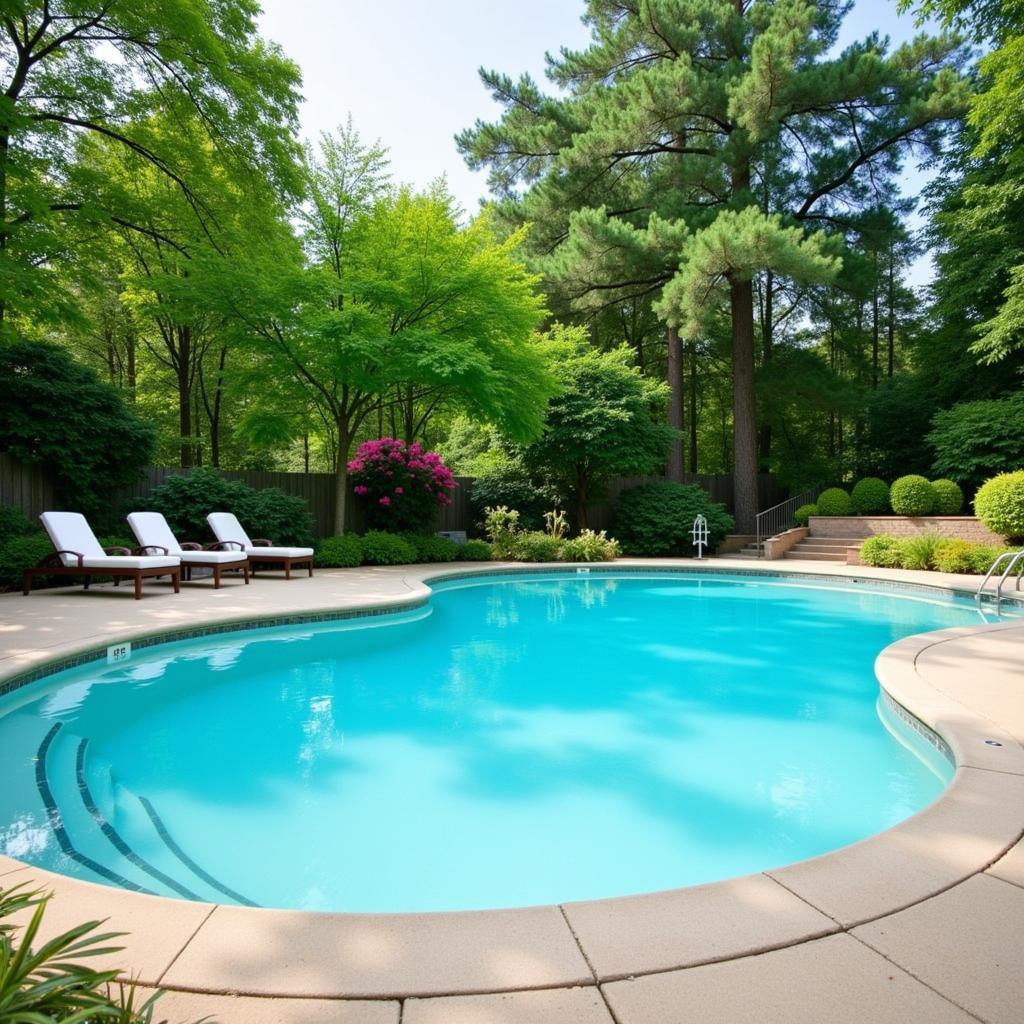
612, 481, 734, 557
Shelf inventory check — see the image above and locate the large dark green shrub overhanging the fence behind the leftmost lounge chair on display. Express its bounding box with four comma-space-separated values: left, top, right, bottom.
0, 342, 154, 514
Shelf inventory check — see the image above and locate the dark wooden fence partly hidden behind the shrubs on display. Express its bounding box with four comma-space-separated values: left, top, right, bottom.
0, 453, 786, 537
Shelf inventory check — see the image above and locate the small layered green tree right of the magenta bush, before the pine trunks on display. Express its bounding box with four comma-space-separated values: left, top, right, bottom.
523, 328, 676, 529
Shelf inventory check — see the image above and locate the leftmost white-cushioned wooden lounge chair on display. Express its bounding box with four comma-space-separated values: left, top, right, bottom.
24, 512, 181, 601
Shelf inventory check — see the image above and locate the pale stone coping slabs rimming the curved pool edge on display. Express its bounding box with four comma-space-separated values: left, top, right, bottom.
0, 559, 1024, 1000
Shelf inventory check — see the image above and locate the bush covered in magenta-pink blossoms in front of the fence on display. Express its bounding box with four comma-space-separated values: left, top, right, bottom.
348, 437, 456, 532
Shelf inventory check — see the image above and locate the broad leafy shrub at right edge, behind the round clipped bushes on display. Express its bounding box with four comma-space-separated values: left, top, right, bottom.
928, 391, 1024, 486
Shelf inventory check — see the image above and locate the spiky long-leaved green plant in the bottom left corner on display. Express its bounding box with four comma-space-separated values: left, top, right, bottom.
0, 885, 178, 1024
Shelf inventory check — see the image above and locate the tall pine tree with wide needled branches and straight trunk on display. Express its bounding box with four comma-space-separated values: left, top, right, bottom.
460, 0, 968, 532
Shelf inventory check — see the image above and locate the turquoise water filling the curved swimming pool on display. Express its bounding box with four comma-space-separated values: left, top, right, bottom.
0, 573, 999, 911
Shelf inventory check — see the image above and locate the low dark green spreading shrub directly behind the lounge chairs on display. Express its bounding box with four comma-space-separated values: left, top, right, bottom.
135, 468, 313, 547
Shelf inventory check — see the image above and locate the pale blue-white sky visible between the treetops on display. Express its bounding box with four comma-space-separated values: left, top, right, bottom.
261, 0, 946, 285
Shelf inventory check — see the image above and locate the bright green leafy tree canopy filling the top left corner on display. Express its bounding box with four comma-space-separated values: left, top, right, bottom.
0, 0, 299, 331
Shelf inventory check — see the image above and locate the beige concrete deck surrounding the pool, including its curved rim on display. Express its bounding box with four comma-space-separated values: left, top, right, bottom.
0, 559, 1024, 1024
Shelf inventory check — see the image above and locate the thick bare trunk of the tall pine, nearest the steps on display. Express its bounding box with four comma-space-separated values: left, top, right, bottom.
729, 278, 758, 534
